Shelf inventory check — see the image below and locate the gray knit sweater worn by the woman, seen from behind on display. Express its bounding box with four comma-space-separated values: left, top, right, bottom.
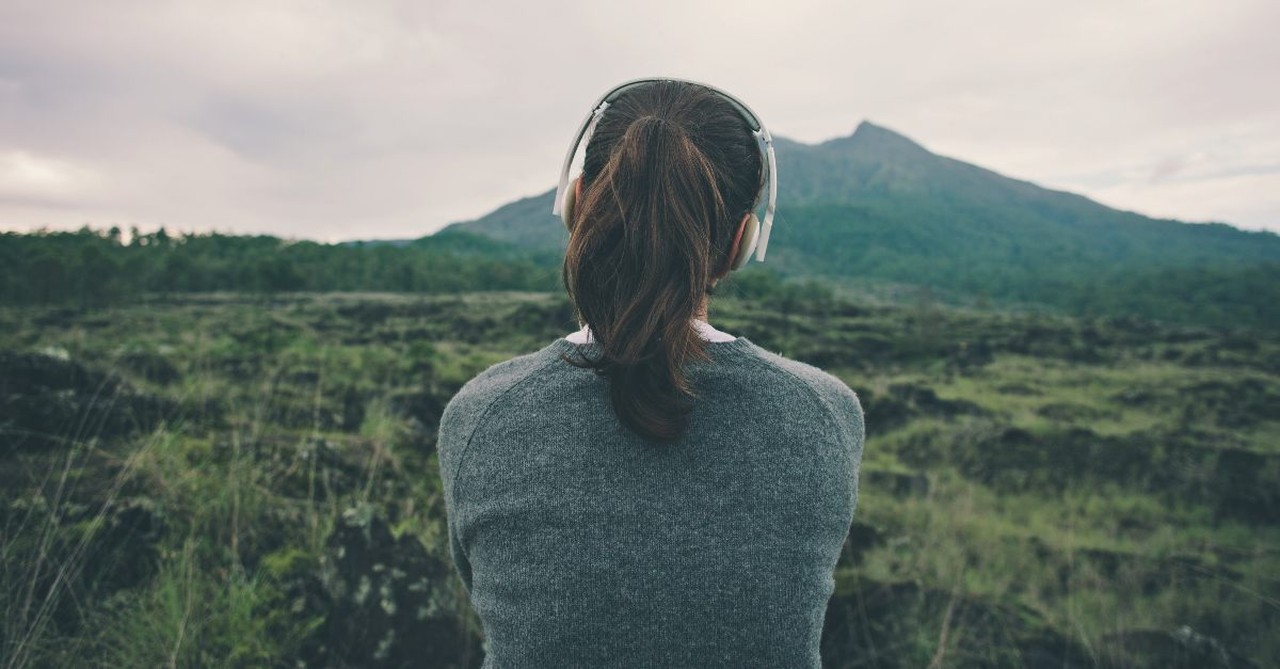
438, 336, 865, 669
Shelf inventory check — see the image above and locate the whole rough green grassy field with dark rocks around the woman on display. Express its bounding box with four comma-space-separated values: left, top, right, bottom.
0, 293, 1280, 668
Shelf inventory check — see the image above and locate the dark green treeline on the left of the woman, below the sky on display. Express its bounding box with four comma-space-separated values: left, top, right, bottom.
0, 228, 559, 306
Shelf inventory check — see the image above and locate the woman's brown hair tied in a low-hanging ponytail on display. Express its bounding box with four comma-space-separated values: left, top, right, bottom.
562, 81, 763, 441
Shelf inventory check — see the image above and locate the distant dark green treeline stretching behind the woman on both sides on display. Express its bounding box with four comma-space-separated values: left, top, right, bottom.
0, 228, 1280, 329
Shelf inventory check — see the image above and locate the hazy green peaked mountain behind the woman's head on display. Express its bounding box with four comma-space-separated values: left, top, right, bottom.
436, 122, 1280, 326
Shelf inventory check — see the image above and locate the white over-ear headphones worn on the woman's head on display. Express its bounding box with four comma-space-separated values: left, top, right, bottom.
552, 77, 778, 271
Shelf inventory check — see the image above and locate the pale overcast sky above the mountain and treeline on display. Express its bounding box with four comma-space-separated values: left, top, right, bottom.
0, 0, 1280, 242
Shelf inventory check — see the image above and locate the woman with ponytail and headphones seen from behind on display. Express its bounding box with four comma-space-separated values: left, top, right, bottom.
438, 79, 864, 668
